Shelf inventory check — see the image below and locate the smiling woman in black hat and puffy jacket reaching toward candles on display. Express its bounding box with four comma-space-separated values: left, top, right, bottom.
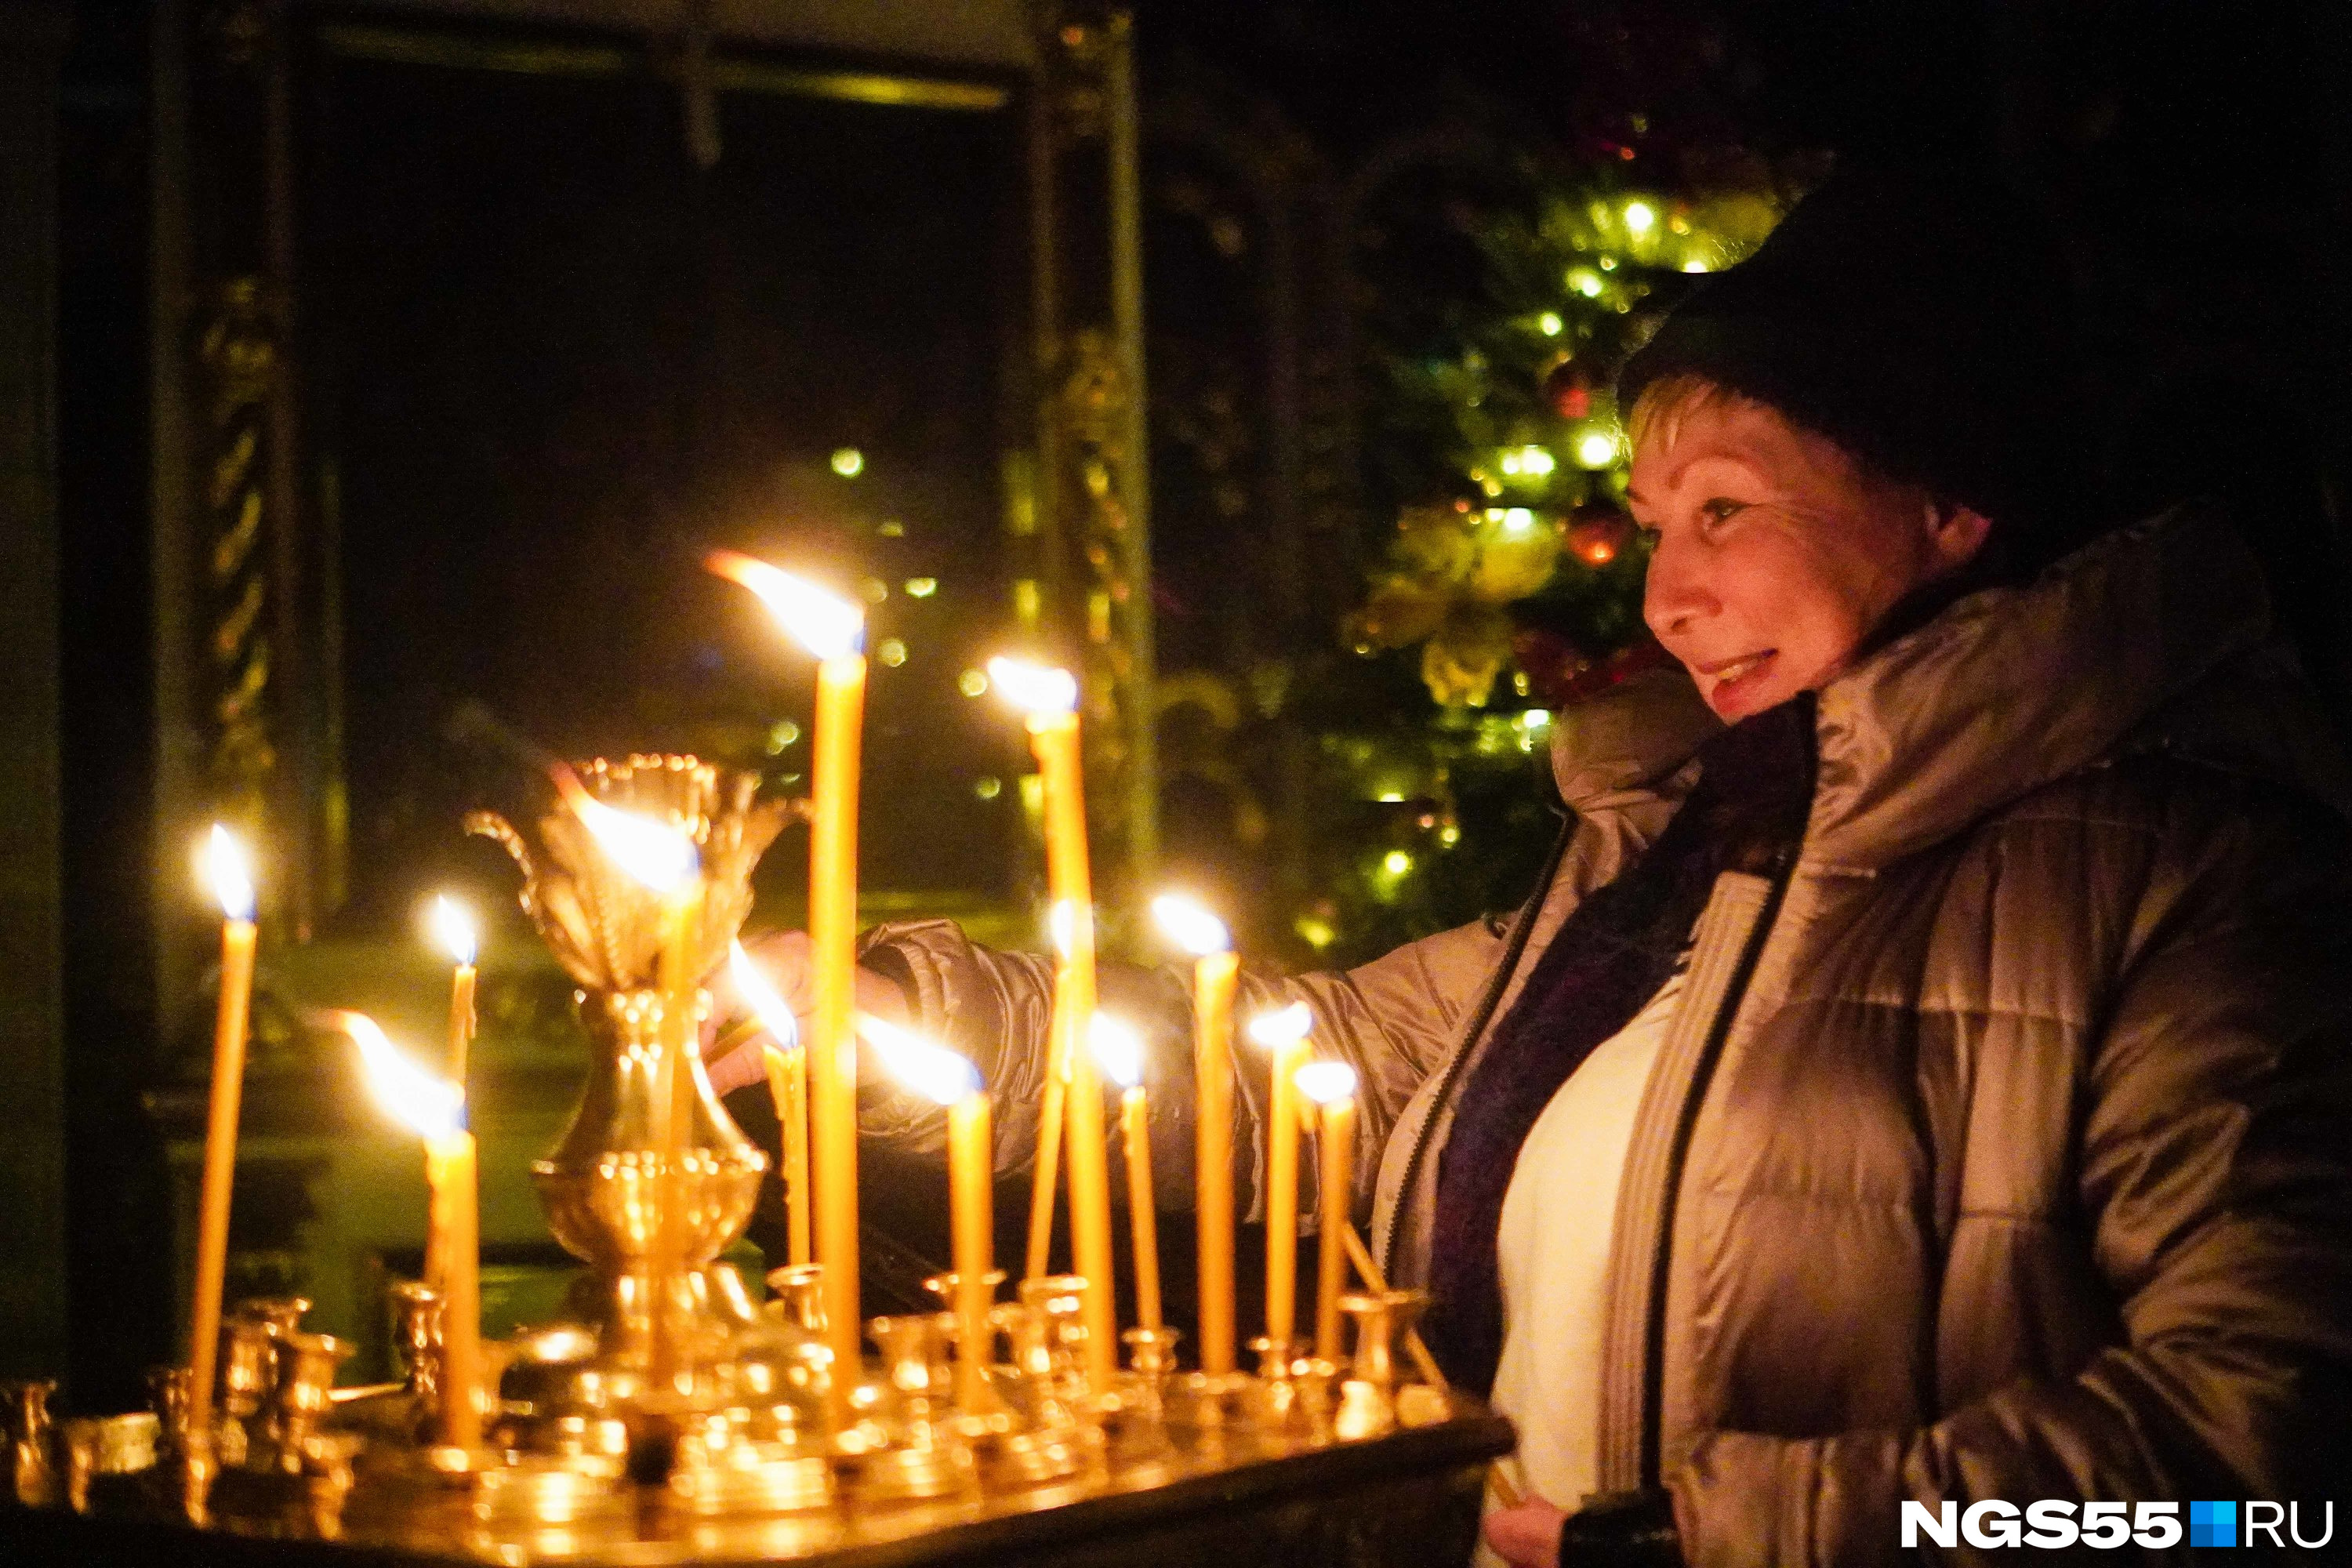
715, 165, 2352, 1566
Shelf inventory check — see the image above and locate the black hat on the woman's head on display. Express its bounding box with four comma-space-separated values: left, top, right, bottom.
1618, 167, 2089, 567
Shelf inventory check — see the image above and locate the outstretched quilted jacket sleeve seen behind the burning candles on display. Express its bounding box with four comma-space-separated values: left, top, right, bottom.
861, 921, 1501, 1215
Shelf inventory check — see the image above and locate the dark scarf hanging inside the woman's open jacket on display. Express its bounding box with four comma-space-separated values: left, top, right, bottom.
1428, 694, 1813, 1396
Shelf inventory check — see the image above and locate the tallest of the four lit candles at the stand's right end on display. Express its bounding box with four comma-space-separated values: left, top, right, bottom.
1152, 893, 1242, 1373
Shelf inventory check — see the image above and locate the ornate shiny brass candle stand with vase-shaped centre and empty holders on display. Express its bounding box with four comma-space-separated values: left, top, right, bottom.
0, 757, 1510, 1563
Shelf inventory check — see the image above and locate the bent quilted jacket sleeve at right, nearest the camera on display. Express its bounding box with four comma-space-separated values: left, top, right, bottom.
1668, 794, 2352, 1568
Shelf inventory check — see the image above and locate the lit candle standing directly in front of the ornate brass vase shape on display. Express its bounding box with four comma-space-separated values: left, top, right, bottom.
572, 794, 703, 1385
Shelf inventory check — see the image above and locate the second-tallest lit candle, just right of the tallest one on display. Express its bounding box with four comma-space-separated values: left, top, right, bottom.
988, 659, 1120, 1394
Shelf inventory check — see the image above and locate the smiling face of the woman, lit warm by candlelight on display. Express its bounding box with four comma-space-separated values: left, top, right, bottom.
1628, 395, 1990, 722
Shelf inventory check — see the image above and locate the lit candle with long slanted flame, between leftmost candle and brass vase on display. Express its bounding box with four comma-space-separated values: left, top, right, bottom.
334, 1013, 482, 1448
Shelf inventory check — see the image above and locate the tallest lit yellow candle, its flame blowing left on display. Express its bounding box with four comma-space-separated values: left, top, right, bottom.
708, 550, 866, 1420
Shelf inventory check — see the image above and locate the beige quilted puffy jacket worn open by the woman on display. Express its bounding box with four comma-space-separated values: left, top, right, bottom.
870, 508, 2352, 1568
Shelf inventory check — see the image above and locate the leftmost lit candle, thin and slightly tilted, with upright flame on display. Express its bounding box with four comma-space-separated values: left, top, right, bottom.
188, 822, 254, 1441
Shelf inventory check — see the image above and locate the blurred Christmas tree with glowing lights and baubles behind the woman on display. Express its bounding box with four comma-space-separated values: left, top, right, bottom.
1294, 162, 1783, 961
